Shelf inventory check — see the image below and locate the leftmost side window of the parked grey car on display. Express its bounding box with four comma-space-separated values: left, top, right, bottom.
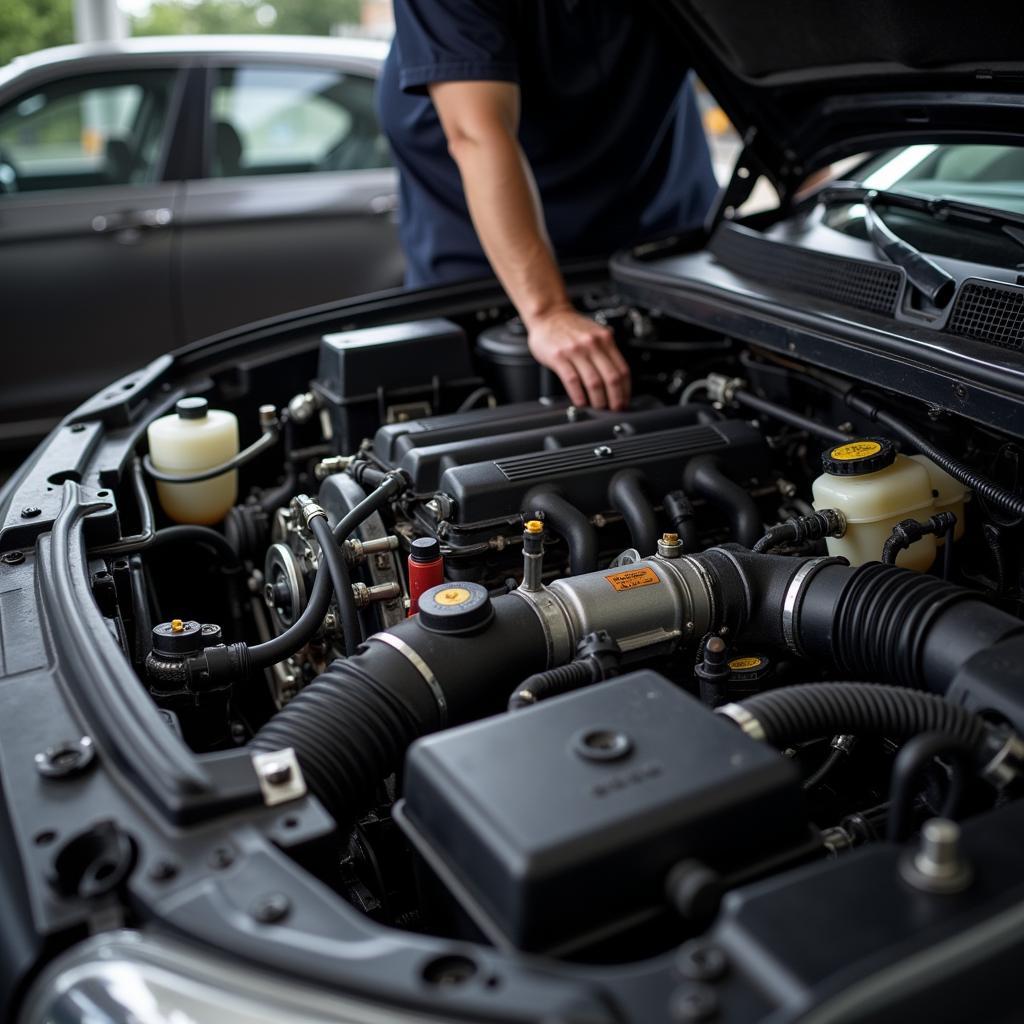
0, 70, 176, 197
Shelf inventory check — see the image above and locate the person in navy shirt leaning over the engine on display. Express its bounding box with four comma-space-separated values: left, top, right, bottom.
378, 0, 716, 409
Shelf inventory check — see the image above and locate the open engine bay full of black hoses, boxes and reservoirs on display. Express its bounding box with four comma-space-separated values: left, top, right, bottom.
6, 274, 1024, 1019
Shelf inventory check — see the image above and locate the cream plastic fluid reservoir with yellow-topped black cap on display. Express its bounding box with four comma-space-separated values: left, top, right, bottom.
811, 437, 935, 571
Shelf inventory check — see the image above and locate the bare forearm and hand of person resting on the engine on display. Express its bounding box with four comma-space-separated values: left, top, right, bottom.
430, 82, 630, 409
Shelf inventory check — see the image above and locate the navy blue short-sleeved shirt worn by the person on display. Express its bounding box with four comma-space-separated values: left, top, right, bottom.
378, 0, 717, 287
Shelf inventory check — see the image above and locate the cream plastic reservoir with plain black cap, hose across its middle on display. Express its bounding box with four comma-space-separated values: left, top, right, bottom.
146, 398, 239, 525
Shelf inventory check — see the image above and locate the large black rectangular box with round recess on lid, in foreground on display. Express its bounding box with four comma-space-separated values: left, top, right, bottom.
395, 671, 807, 952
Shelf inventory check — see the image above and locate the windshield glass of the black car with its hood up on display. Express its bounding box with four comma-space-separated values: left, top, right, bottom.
857, 145, 1024, 214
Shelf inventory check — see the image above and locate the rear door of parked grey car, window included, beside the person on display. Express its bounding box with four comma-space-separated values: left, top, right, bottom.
181, 60, 402, 339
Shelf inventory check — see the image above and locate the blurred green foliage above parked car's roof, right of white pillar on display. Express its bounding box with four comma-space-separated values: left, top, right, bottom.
132, 0, 359, 36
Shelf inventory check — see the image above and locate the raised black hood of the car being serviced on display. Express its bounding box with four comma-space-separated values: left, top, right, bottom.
668, 0, 1024, 194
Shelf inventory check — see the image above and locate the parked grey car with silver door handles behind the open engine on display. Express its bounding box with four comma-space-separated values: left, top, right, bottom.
0, 36, 401, 443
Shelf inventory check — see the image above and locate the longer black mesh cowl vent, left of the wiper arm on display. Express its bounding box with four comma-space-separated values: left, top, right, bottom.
710, 224, 903, 316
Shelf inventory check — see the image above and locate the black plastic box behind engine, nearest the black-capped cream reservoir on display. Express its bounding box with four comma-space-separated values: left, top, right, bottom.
312, 318, 482, 453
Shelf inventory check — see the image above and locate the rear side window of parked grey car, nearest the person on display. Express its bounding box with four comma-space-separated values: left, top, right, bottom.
209, 67, 390, 177
